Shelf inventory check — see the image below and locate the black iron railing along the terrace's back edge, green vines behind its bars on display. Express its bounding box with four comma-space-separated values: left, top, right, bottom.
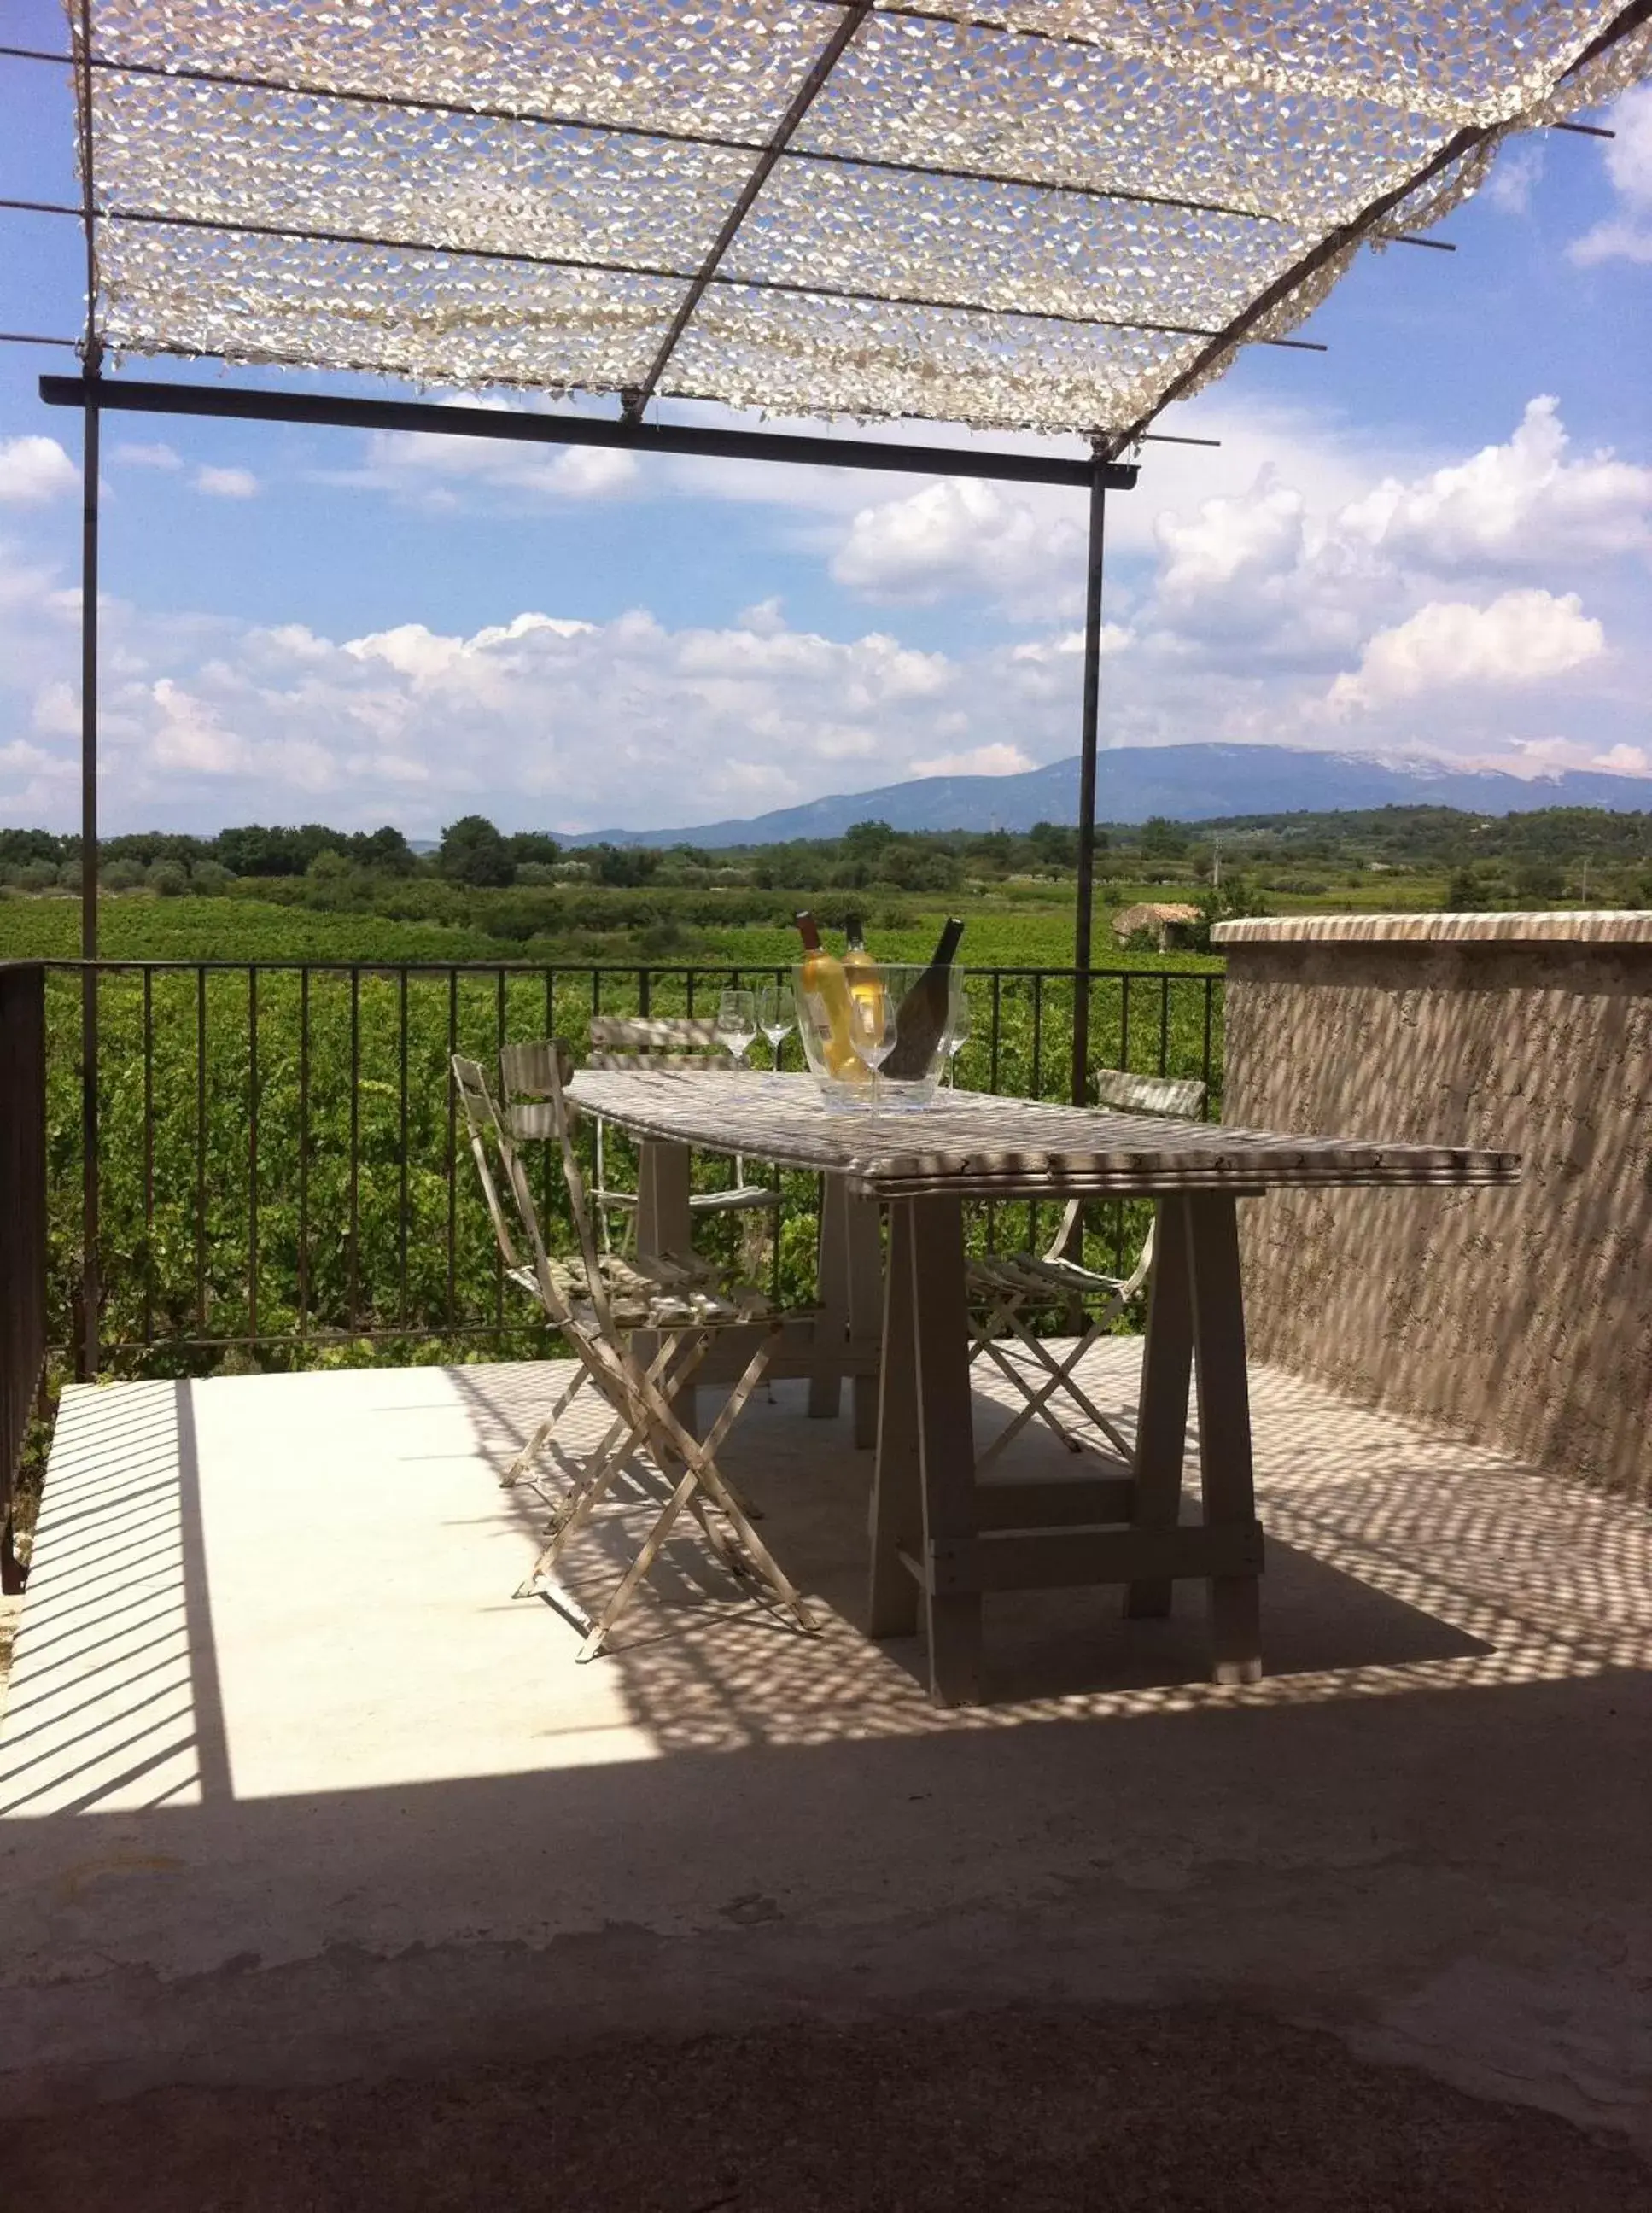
32, 961, 1223, 1372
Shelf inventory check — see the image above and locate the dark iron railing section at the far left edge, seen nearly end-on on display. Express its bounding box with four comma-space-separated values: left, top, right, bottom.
0, 963, 46, 1591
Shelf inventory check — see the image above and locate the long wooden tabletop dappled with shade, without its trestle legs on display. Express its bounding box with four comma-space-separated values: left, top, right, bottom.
570, 1069, 1520, 1197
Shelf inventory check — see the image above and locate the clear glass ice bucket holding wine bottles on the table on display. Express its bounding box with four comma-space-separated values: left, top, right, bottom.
791, 961, 964, 1113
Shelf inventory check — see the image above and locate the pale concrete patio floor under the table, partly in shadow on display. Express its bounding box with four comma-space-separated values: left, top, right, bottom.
0, 1339, 1652, 2156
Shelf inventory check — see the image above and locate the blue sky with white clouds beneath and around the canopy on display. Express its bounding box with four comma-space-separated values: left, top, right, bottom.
0, 0, 1652, 834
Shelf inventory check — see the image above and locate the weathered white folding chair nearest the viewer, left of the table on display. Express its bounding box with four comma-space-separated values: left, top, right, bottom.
453, 1051, 814, 1660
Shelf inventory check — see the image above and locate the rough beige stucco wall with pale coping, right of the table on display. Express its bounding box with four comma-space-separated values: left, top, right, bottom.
1218, 916, 1652, 1498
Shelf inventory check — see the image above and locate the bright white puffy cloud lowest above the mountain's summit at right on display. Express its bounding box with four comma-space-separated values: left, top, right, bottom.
1329, 591, 1606, 713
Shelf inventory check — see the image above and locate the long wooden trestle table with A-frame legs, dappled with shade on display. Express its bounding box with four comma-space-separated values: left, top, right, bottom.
570, 1071, 1520, 1706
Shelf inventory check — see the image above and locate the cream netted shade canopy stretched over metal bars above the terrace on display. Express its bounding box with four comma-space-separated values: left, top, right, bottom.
68, 0, 1652, 452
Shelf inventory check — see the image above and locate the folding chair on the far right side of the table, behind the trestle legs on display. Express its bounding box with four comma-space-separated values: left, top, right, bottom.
969, 1069, 1205, 1474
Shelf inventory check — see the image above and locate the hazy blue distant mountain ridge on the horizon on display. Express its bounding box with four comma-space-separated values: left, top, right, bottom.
564, 746, 1652, 845
